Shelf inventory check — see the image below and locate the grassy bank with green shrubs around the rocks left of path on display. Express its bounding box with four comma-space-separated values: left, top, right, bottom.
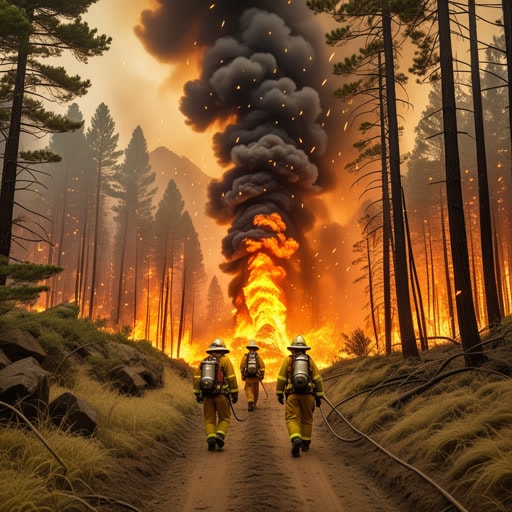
0, 310, 195, 512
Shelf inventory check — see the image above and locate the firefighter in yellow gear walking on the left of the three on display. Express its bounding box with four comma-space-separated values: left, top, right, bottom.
194, 338, 238, 451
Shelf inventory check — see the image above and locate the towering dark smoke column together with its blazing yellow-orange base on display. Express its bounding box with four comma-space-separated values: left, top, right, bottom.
138, 0, 334, 350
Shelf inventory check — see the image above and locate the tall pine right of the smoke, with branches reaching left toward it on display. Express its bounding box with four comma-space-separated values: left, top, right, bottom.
308, 0, 422, 359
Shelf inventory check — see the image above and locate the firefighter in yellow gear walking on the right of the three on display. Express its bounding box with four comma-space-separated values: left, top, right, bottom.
276, 335, 324, 457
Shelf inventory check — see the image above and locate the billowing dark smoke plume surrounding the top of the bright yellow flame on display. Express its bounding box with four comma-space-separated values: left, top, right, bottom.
136, 0, 362, 340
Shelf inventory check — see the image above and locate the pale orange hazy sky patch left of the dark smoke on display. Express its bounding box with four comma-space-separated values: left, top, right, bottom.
66, 0, 222, 175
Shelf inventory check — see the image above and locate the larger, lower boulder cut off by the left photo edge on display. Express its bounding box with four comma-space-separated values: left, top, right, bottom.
0, 357, 50, 422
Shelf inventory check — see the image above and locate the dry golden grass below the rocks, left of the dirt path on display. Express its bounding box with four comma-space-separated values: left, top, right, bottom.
0, 368, 195, 512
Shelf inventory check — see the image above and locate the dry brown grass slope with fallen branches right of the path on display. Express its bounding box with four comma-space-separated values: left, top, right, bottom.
325, 322, 512, 512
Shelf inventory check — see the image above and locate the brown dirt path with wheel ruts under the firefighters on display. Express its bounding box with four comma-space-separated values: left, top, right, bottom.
143, 383, 400, 512
